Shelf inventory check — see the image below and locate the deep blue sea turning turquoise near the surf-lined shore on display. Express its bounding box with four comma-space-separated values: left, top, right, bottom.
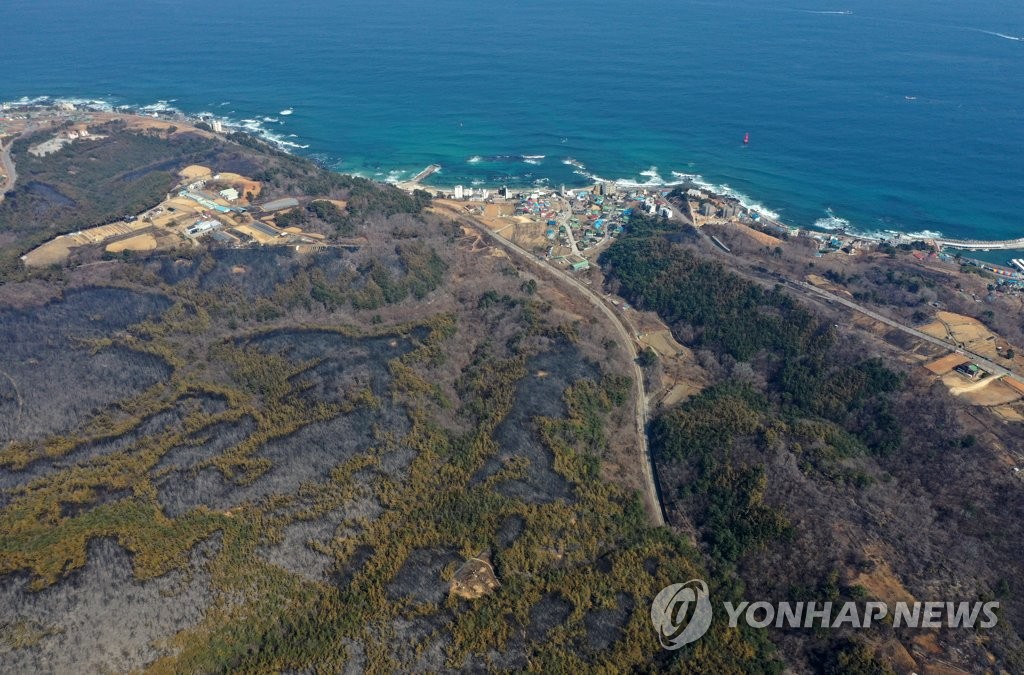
0, 0, 1024, 238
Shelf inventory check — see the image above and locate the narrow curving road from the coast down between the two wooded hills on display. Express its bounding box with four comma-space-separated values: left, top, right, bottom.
434, 202, 665, 526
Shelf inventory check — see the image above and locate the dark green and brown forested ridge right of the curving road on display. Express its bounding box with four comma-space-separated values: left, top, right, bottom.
601, 216, 1024, 672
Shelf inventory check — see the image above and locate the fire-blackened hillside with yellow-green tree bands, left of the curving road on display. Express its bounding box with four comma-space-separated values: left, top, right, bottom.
0, 120, 778, 672
